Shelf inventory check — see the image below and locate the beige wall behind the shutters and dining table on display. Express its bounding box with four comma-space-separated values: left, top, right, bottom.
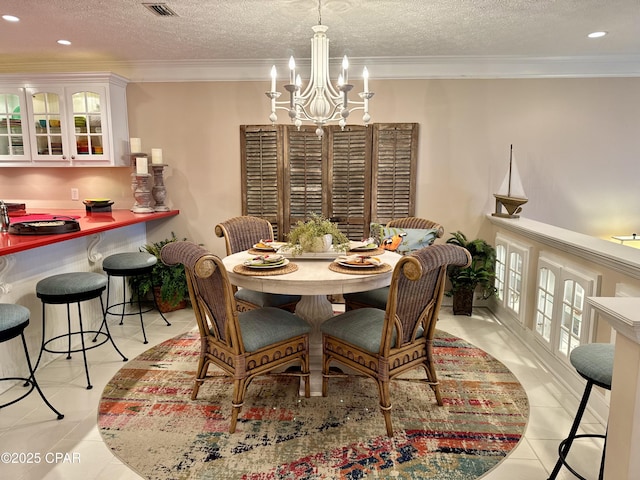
0, 77, 640, 254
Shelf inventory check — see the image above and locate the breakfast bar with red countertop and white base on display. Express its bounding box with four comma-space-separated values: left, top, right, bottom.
0, 208, 180, 387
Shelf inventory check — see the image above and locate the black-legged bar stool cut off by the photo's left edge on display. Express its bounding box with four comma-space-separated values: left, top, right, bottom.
0, 303, 64, 420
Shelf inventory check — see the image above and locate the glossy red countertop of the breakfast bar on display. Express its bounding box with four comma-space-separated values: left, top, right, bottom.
0, 209, 180, 256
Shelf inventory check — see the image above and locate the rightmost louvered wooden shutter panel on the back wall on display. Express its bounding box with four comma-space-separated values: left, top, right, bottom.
372, 123, 418, 224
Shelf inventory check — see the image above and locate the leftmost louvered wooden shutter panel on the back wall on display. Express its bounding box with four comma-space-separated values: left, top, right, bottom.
240, 125, 282, 239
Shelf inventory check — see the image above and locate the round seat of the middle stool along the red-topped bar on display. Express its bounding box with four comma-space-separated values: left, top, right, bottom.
36, 272, 107, 303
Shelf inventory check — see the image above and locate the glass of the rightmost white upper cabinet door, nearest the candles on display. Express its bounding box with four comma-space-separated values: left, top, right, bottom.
71, 92, 104, 156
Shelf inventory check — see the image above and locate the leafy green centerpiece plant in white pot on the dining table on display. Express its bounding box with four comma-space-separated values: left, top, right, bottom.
286, 214, 349, 255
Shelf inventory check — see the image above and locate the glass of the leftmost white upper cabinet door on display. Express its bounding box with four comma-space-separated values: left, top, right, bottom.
0, 92, 29, 161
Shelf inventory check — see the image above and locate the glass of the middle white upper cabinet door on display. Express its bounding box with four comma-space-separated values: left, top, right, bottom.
32, 92, 64, 156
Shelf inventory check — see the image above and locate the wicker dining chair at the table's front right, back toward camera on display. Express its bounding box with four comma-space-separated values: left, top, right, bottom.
320, 245, 471, 437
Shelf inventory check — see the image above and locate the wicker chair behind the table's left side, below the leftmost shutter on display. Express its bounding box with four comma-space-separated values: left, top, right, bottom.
215, 215, 300, 312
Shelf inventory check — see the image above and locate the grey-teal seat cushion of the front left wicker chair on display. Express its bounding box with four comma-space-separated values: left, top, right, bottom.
238, 307, 311, 352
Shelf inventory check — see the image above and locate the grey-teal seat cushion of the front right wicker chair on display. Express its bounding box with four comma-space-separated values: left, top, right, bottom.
320, 308, 424, 353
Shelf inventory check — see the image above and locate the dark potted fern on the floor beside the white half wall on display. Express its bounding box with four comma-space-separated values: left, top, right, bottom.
446, 231, 497, 316
